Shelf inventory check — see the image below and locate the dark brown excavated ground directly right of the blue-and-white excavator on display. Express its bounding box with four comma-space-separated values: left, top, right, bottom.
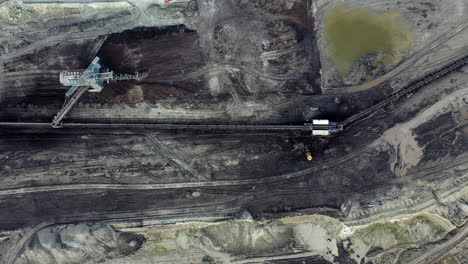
91, 26, 206, 103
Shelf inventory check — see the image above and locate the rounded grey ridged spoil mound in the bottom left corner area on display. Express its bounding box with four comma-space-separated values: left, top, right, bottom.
15, 224, 144, 264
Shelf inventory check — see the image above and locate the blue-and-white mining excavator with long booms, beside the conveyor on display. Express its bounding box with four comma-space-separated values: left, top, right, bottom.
51, 57, 147, 128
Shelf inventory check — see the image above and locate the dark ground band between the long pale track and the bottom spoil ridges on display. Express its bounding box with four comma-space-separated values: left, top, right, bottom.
0, 161, 392, 229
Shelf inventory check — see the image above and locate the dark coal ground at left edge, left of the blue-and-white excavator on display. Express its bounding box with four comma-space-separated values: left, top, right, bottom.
0, 40, 98, 108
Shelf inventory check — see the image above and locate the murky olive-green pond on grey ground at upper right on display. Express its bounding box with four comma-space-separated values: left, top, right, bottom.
325, 7, 412, 74
